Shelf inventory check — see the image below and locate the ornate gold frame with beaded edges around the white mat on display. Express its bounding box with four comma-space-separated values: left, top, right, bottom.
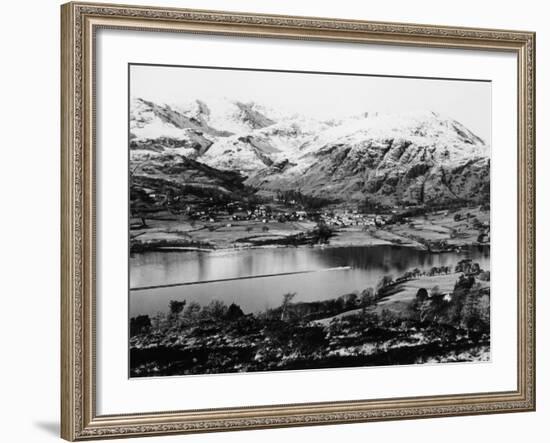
61, 3, 535, 441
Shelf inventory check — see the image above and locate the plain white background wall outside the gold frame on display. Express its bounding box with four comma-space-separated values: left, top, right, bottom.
0, 0, 550, 443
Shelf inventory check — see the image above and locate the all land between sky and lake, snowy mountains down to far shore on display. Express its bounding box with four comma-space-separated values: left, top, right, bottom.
130, 99, 490, 252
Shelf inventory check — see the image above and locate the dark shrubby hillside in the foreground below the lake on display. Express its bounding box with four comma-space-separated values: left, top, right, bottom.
130, 260, 490, 377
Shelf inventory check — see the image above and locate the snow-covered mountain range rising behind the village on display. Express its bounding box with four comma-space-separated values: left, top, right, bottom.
130, 98, 490, 204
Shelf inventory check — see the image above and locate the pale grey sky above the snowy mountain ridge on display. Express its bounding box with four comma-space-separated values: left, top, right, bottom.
130, 65, 491, 142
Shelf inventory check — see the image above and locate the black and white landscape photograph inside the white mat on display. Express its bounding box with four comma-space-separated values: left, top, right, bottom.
128, 64, 492, 378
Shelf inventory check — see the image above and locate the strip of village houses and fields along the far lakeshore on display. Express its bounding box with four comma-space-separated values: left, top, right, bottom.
130, 193, 490, 253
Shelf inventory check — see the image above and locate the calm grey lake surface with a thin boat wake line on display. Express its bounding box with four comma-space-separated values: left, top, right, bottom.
130, 245, 490, 317
